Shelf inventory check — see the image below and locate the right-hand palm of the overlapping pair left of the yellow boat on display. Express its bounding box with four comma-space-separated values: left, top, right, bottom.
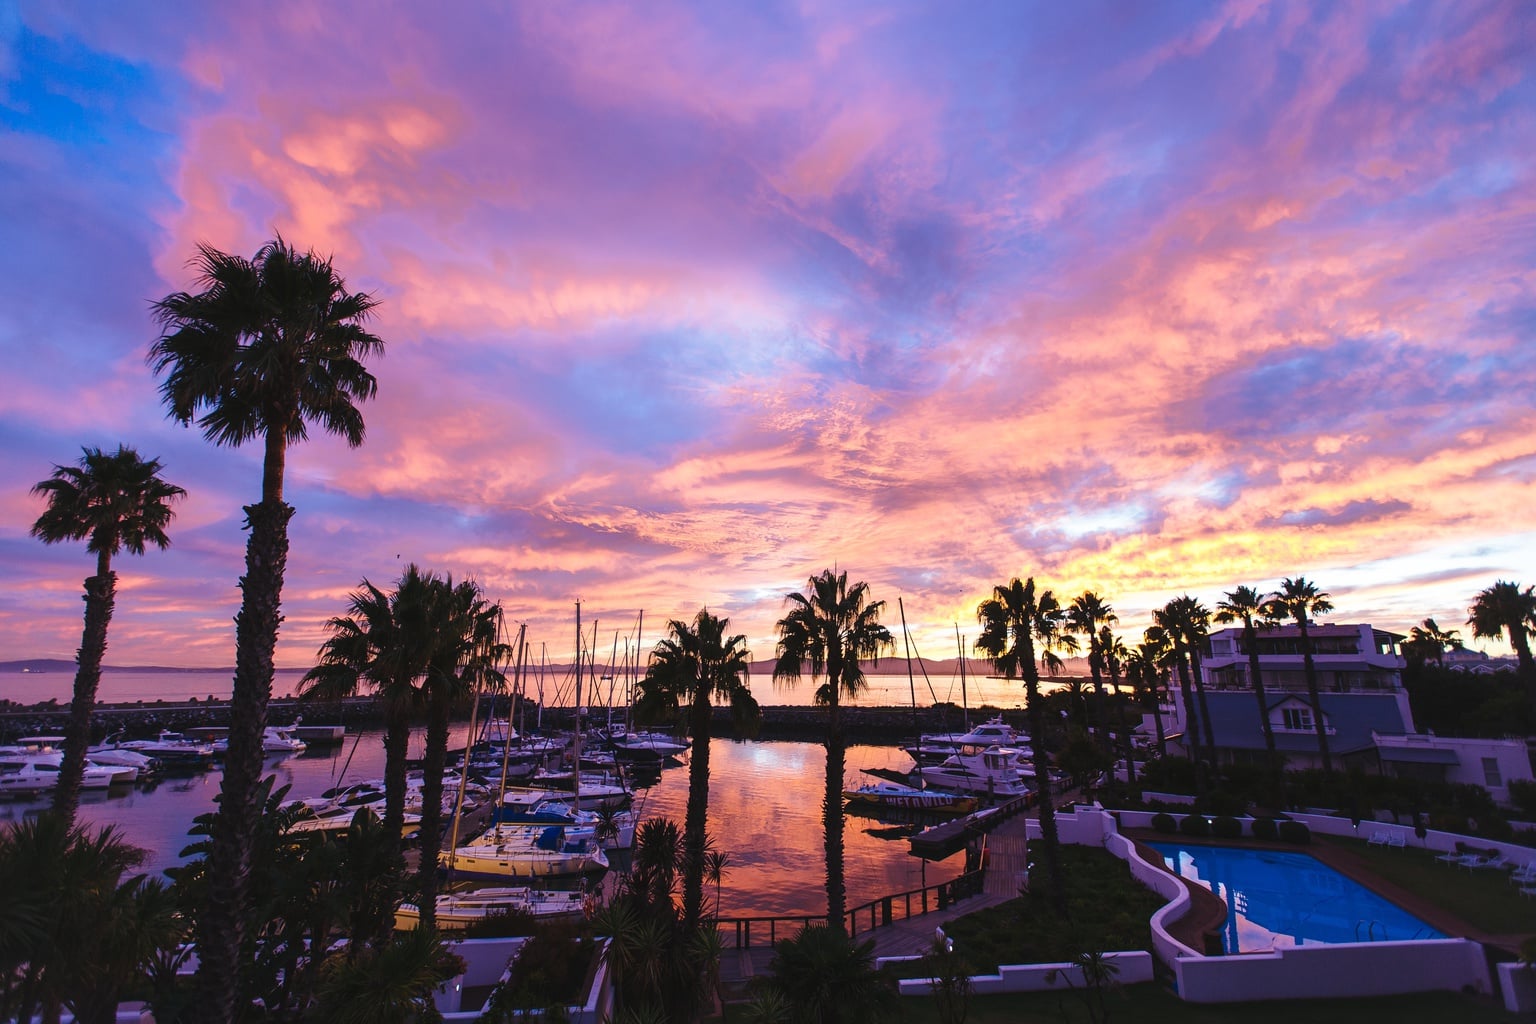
416, 576, 510, 927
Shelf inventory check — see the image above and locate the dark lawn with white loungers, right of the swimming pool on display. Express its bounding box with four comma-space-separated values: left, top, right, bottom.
1318, 837, 1536, 935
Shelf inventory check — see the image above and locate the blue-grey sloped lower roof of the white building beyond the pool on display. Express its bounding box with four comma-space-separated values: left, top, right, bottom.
1195, 689, 1409, 754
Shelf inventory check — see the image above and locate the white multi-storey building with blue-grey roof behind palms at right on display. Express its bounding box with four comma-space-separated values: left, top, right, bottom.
1164, 623, 1531, 803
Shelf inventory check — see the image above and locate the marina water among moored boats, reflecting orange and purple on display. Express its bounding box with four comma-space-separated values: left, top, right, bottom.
0, 726, 962, 917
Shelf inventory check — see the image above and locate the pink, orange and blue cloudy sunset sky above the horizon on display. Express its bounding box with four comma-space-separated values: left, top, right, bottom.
0, 0, 1536, 668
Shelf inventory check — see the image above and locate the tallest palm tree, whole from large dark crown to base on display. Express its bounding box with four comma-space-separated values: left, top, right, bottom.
149, 238, 384, 1021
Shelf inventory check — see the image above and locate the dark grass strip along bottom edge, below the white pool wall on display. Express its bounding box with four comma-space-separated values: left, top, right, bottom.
902, 984, 1530, 1024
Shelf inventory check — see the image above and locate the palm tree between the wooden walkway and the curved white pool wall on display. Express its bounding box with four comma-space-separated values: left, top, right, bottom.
975, 576, 1071, 918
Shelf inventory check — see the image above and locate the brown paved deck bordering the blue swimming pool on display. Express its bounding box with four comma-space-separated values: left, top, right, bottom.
1124, 829, 1536, 955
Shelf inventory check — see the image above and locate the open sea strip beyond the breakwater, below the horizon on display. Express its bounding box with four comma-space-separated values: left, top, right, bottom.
0, 662, 1051, 708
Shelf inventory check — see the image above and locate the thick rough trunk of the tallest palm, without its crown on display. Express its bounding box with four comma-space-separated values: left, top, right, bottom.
197, 499, 293, 1024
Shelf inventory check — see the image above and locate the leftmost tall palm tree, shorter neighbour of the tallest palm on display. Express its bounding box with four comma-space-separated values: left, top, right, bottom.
32, 445, 186, 829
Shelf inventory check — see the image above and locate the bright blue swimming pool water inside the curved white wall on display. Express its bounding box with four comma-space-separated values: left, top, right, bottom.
1149, 843, 1445, 953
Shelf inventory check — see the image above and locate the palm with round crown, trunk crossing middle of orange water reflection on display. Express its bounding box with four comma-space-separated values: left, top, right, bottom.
773, 570, 892, 932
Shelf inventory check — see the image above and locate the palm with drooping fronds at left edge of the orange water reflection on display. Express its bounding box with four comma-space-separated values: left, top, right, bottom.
636, 608, 762, 929
